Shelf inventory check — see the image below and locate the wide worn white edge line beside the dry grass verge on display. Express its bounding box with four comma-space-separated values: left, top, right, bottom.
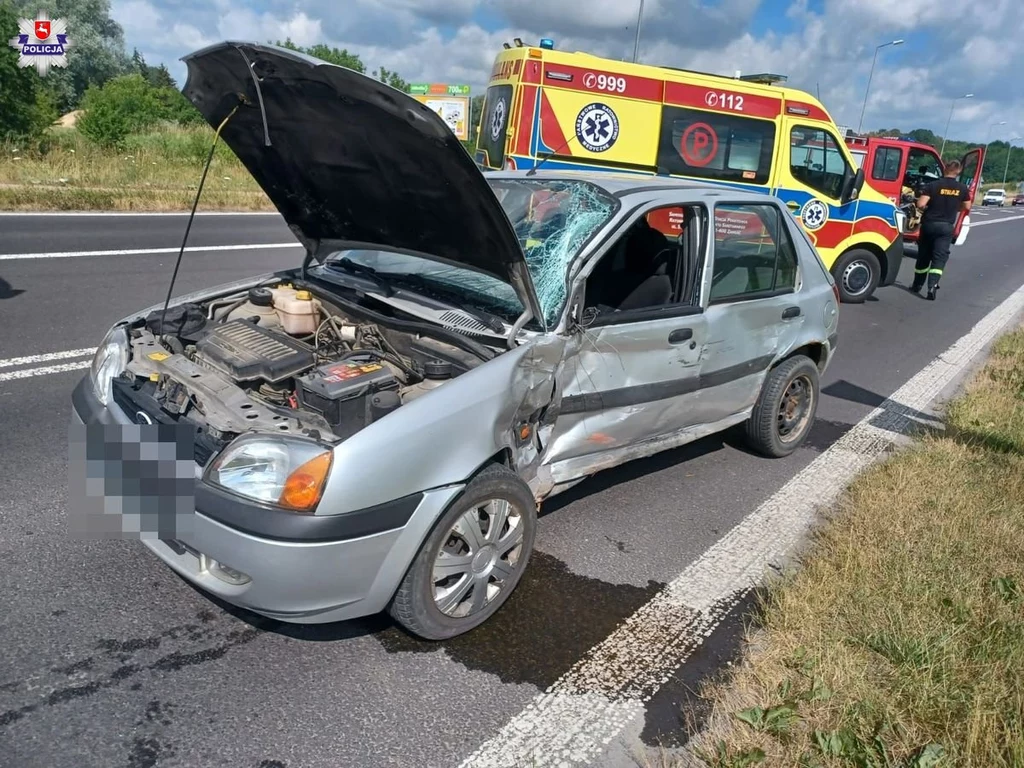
461, 287, 1024, 768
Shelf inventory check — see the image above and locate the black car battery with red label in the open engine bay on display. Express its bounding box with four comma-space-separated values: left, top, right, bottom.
296, 355, 398, 437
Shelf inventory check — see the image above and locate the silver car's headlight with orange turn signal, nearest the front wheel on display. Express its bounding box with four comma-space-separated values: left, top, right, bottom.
205, 436, 334, 513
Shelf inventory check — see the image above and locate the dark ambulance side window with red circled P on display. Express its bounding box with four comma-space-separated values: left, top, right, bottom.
657, 106, 775, 184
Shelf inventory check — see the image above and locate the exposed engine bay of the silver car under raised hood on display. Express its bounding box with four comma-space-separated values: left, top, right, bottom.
113, 280, 500, 463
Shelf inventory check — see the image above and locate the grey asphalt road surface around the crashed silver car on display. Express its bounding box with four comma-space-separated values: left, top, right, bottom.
6, 208, 1024, 768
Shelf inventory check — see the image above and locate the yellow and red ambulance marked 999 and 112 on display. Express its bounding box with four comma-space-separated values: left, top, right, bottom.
476, 39, 906, 303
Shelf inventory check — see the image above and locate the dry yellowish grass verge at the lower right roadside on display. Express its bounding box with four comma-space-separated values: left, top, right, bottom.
684, 330, 1024, 768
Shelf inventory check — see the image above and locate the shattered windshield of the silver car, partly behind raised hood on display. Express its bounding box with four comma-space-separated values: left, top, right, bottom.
315, 178, 618, 326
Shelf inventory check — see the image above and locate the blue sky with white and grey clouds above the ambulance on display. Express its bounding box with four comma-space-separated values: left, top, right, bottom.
113, 0, 1024, 142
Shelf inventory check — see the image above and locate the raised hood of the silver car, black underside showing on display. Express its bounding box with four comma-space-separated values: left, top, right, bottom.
181, 42, 544, 327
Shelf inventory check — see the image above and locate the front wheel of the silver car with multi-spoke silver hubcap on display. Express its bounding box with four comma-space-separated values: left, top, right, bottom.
388, 464, 537, 640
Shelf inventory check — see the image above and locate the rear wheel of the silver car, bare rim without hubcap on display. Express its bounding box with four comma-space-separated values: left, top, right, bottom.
746, 354, 819, 459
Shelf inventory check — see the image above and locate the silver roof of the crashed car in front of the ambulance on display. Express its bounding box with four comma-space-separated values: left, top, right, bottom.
483, 170, 774, 203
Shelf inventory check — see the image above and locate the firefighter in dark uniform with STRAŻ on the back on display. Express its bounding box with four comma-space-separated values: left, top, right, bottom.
910, 160, 971, 301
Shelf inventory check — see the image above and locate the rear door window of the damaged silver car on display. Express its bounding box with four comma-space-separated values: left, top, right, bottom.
711, 204, 797, 303
